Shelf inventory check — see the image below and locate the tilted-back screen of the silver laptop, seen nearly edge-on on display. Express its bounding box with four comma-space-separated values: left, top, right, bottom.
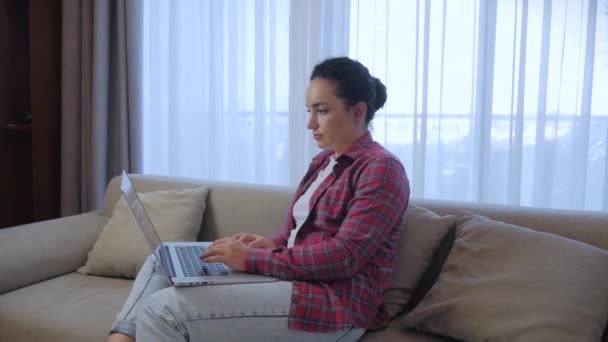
120, 170, 162, 261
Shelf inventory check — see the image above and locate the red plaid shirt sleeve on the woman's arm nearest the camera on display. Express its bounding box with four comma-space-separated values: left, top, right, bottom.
245, 158, 409, 280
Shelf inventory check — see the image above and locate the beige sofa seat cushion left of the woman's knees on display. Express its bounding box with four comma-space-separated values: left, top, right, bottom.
0, 273, 133, 342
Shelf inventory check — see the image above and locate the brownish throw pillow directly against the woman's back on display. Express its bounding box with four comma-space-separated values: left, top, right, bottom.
383, 203, 456, 318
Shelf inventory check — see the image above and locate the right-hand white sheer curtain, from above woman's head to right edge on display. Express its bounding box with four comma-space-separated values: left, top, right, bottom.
350, 0, 608, 210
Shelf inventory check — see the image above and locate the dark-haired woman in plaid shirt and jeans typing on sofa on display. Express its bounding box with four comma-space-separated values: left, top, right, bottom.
108, 57, 409, 341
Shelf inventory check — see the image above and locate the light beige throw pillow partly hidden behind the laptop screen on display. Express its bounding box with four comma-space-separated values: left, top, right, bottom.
77, 187, 208, 278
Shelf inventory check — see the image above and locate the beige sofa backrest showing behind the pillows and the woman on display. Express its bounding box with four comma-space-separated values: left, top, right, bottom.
102, 175, 608, 249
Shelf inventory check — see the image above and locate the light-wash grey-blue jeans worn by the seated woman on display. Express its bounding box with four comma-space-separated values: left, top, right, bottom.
111, 256, 365, 342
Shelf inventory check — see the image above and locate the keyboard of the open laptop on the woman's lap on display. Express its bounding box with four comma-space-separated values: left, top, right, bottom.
175, 246, 230, 277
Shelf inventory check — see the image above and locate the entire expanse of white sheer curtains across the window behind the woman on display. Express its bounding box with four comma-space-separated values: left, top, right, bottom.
144, 0, 608, 210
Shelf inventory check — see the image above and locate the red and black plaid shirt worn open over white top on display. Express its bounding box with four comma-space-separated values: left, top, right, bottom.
246, 133, 410, 332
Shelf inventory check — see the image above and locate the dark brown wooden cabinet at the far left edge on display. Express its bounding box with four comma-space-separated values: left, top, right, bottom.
0, 0, 61, 228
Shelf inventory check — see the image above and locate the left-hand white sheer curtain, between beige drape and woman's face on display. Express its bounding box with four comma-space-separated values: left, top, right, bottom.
144, 0, 350, 185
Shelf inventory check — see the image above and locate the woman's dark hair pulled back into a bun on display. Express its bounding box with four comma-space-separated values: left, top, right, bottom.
310, 57, 386, 125
